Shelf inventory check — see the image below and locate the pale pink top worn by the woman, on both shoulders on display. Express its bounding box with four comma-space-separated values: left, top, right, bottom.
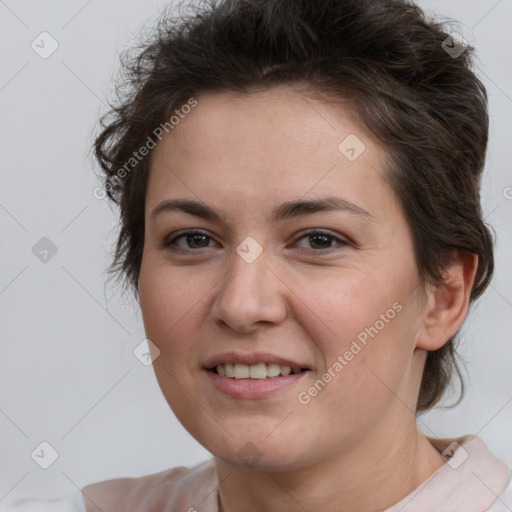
5, 435, 512, 512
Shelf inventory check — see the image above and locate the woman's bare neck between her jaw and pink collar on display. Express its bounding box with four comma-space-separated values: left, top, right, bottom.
215, 422, 444, 512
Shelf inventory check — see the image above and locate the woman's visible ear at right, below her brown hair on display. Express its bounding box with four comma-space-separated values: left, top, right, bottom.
416, 252, 478, 350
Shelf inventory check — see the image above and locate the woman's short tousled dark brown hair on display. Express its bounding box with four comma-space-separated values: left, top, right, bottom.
94, 0, 494, 412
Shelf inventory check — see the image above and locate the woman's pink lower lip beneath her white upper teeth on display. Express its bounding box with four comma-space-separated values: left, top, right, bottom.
205, 370, 309, 398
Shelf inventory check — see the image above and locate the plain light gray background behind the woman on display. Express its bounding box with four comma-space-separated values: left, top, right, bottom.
0, 0, 512, 503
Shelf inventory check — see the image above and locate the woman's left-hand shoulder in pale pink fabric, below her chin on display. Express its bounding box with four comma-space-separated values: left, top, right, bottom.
82, 459, 218, 512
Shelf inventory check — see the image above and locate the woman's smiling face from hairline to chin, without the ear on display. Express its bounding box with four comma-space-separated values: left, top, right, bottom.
139, 87, 425, 468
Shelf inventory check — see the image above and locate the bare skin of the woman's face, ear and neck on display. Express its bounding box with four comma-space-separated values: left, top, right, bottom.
130, 86, 477, 512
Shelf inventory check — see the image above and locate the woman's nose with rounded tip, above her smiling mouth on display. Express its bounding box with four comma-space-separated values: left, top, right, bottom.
210, 246, 287, 333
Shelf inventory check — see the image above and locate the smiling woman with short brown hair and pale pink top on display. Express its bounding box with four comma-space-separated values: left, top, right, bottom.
9, 0, 512, 512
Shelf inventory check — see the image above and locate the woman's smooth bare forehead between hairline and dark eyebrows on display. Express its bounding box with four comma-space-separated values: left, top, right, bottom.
147, 86, 389, 220
